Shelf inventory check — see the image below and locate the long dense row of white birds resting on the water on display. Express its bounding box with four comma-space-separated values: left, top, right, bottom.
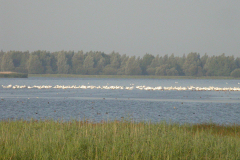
2, 84, 240, 91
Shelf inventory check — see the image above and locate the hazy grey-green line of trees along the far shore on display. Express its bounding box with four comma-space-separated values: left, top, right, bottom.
0, 50, 240, 77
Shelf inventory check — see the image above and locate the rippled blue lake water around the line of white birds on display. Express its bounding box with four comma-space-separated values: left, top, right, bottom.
0, 77, 240, 124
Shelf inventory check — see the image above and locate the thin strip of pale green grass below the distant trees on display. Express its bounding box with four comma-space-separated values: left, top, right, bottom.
28, 74, 240, 79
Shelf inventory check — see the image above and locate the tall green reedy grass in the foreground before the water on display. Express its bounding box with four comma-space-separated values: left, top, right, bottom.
0, 120, 240, 160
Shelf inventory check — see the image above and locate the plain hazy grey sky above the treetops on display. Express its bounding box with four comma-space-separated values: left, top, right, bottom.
0, 0, 240, 57
